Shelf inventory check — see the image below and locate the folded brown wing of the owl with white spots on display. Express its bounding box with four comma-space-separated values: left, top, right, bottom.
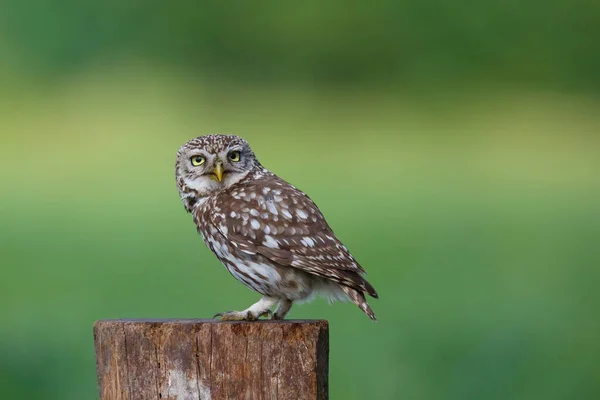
210, 173, 377, 297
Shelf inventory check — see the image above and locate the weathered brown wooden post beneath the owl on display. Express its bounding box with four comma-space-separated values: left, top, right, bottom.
94, 319, 329, 400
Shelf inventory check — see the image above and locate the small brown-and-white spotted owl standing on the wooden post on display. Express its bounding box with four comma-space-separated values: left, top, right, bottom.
175, 135, 378, 321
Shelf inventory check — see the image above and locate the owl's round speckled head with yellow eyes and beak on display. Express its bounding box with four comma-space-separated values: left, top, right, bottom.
175, 135, 261, 211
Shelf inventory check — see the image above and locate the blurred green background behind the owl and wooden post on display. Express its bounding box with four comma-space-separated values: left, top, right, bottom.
0, 0, 600, 400
